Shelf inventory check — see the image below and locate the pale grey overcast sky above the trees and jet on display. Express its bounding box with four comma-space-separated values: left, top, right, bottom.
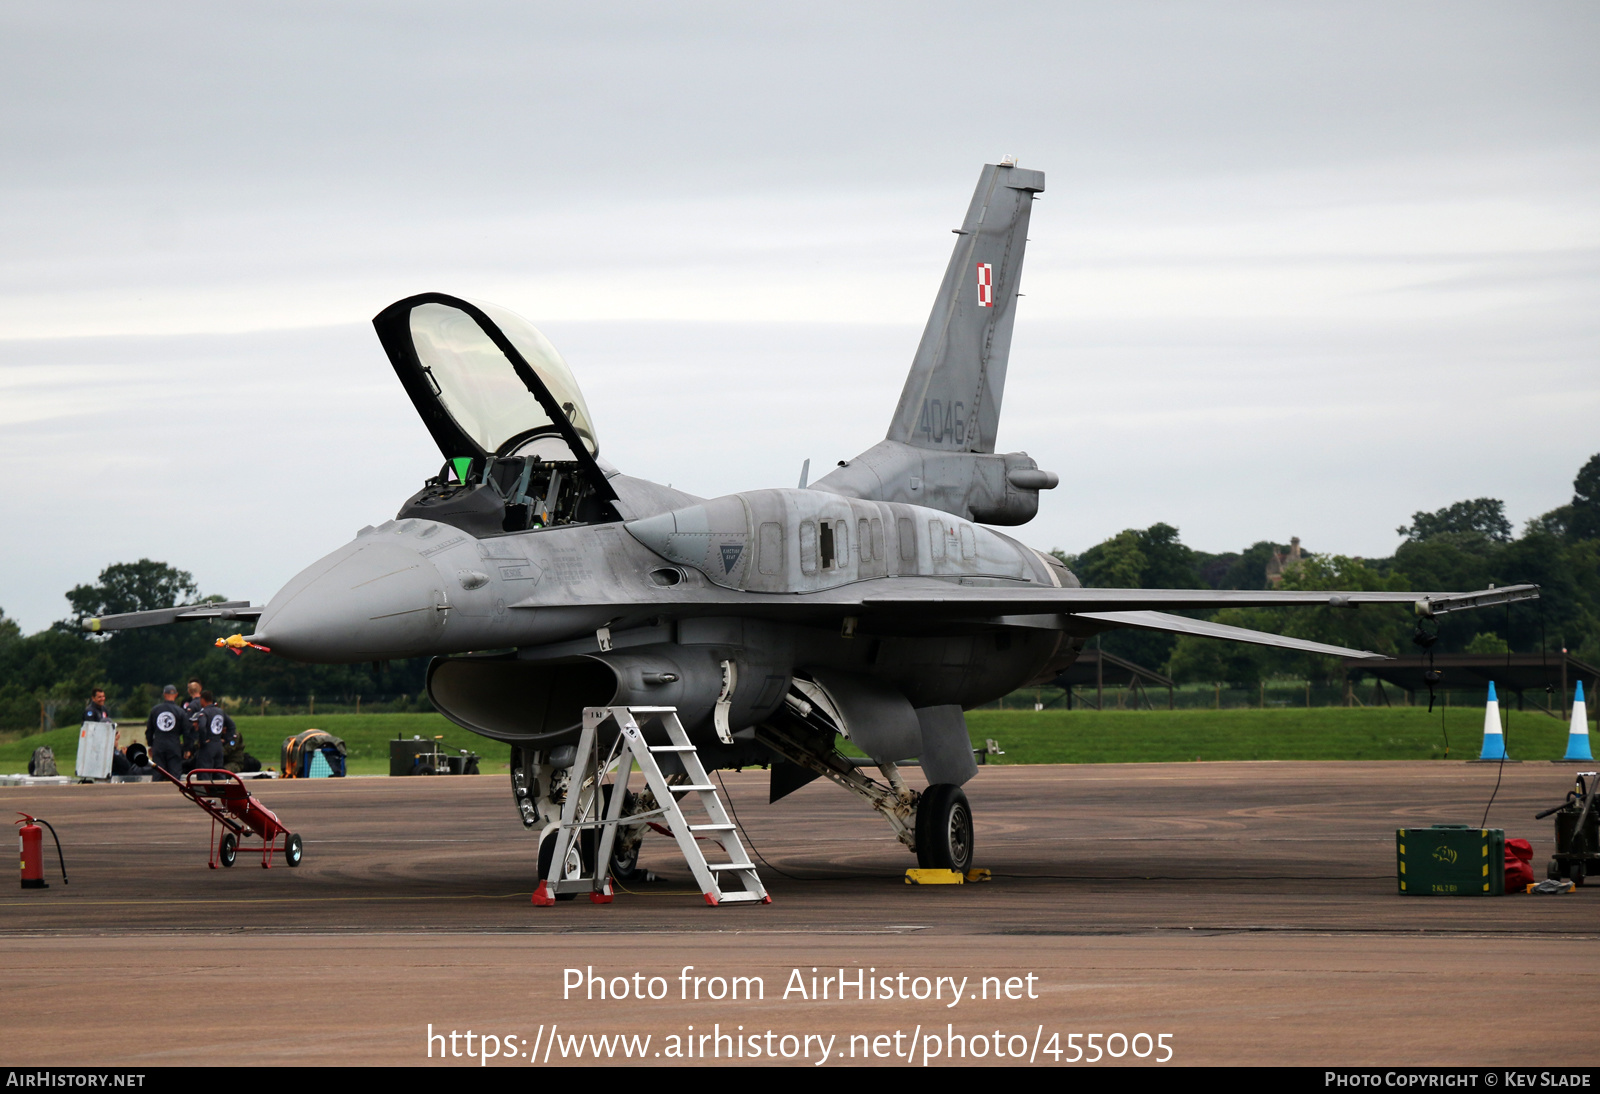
0, 0, 1600, 630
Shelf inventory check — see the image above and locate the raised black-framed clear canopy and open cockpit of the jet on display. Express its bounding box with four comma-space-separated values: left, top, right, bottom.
373, 293, 616, 534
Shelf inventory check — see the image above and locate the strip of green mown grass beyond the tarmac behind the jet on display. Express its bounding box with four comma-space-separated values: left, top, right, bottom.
0, 707, 1587, 774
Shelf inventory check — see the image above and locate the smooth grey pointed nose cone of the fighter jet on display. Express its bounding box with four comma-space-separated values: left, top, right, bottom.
253, 541, 450, 662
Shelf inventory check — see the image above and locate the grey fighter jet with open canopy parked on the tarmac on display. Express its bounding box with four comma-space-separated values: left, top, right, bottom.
90, 162, 1538, 876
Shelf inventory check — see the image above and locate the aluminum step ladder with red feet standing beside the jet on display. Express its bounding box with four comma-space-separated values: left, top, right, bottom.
533, 707, 773, 907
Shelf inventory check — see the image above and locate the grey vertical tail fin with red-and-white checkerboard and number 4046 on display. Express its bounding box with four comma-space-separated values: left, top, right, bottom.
888, 163, 1045, 453
